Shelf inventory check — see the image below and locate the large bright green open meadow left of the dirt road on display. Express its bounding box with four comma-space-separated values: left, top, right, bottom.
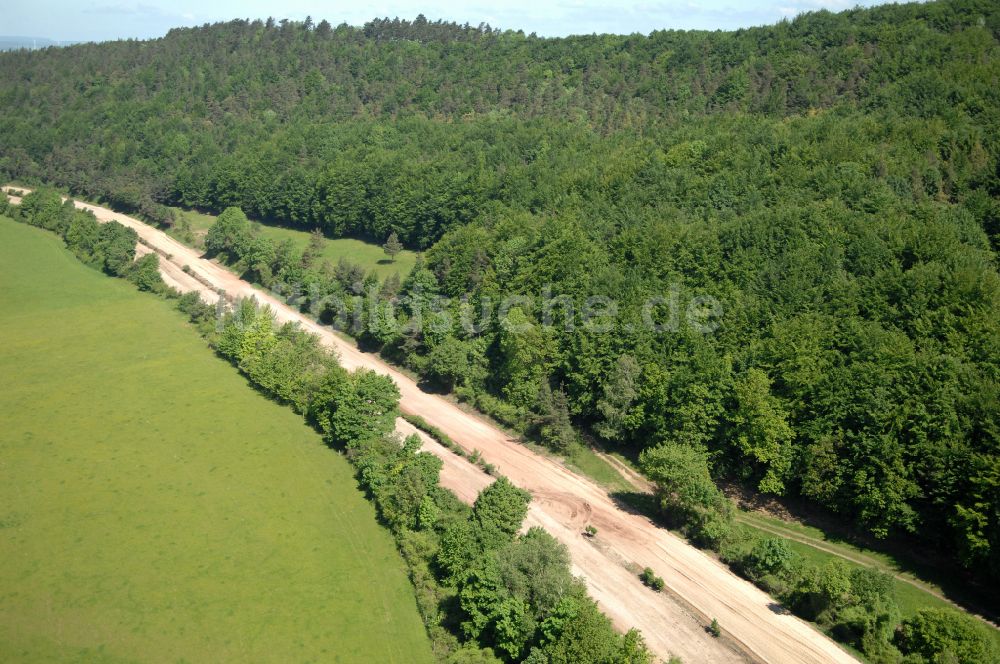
0, 218, 432, 663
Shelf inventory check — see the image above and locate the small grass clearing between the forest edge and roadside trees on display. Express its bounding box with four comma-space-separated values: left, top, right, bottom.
170, 208, 417, 279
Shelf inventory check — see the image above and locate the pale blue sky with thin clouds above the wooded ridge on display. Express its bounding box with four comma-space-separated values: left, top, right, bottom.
0, 0, 896, 41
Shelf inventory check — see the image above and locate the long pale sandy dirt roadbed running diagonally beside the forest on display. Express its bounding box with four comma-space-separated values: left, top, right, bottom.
3, 185, 856, 664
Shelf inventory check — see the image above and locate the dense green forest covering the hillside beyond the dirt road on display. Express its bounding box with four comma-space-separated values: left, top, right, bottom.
0, 0, 1000, 600
